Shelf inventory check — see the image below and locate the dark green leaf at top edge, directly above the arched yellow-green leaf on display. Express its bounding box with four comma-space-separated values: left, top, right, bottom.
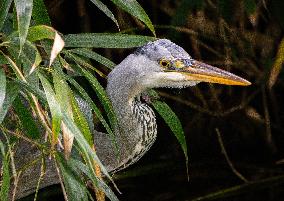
32, 0, 51, 26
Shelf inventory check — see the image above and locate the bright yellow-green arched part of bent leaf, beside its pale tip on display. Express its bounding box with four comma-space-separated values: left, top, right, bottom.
27, 25, 55, 42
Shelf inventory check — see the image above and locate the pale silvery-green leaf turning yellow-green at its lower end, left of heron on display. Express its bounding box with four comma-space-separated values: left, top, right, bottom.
39, 74, 62, 145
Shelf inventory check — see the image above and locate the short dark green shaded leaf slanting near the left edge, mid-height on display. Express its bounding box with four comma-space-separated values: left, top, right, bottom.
13, 97, 41, 139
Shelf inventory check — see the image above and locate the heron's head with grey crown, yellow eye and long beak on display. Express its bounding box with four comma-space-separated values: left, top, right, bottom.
134, 39, 251, 87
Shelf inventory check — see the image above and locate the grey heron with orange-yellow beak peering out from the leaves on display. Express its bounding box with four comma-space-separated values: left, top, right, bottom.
8, 39, 251, 199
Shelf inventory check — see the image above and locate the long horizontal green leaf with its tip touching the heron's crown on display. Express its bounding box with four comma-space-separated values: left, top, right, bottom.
64, 33, 155, 48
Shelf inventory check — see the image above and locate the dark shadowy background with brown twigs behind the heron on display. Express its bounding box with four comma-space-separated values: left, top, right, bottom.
20, 0, 284, 201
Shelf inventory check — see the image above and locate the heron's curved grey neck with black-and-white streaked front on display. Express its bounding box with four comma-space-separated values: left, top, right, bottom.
107, 77, 157, 169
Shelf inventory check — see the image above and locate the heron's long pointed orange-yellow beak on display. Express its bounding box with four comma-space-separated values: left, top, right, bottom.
178, 60, 251, 86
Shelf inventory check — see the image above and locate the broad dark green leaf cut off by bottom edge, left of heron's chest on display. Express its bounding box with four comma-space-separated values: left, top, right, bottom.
56, 155, 88, 201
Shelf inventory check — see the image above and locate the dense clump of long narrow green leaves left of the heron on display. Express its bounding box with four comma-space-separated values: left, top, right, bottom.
0, 0, 184, 200
